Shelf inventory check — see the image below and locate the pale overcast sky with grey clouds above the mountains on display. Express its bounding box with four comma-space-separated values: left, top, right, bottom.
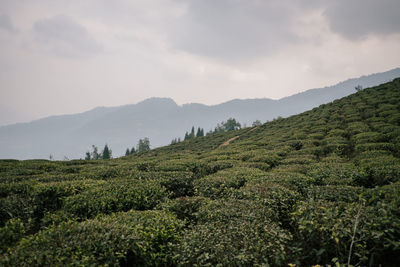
0, 0, 400, 125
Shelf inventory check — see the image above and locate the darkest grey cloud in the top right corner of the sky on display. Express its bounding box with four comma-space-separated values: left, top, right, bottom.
325, 0, 400, 39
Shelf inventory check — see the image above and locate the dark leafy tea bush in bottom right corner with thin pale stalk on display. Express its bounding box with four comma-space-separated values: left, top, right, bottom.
293, 200, 400, 266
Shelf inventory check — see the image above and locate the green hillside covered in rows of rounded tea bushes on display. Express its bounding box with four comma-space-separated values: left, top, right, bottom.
0, 79, 400, 266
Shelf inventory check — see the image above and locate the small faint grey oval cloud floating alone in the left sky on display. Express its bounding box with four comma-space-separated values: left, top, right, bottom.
33, 16, 102, 57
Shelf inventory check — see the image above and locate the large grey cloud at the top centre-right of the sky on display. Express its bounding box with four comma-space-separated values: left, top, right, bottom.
170, 0, 297, 61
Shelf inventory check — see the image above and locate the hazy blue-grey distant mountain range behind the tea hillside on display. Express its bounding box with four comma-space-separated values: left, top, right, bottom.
0, 68, 400, 159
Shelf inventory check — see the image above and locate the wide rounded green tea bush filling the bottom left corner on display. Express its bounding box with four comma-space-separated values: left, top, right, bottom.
0, 211, 182, 266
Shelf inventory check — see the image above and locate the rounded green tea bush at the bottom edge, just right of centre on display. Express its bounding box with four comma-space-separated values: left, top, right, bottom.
174, 200, 293, 266
